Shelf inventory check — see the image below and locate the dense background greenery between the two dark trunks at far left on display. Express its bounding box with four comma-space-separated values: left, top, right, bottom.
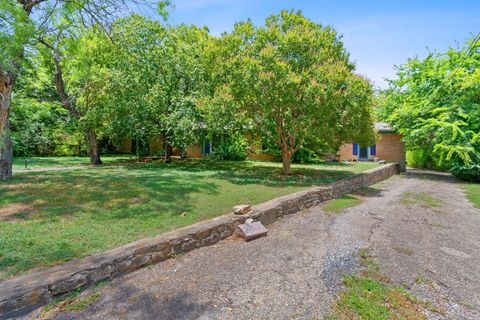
10, 53, 81, 156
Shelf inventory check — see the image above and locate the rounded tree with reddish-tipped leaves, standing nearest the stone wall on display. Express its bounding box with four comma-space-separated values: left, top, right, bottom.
211, 10, 374, 175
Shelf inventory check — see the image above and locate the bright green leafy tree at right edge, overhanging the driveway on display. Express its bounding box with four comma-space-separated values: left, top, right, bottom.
378, 41, 480, 178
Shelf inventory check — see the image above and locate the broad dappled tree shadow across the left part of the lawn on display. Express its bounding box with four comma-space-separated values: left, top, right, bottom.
0, 167, 219, 220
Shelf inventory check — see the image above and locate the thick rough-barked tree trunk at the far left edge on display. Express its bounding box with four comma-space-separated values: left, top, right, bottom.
0, 70, 14, 180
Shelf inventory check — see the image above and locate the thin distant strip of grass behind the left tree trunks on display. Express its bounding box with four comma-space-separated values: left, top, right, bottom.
13, 155, 130, 171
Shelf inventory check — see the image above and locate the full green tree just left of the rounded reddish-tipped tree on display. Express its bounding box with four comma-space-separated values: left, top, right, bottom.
84, 15, 211, 161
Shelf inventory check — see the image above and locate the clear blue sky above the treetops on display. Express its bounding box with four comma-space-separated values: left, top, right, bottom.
162, 0, 480, 88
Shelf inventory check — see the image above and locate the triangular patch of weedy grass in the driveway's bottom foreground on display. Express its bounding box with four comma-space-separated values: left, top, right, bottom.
326, 250, 434, 320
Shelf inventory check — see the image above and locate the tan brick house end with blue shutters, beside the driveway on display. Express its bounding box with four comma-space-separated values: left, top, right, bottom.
337, 122, 406, 170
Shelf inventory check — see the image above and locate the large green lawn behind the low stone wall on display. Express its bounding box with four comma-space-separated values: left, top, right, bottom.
0, 160, 377, 279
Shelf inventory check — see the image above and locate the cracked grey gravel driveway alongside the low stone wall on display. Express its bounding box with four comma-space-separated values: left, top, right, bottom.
28, 171, 480, 320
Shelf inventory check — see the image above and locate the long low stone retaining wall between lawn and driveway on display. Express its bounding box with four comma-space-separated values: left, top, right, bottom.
0, 163, 400, 319
